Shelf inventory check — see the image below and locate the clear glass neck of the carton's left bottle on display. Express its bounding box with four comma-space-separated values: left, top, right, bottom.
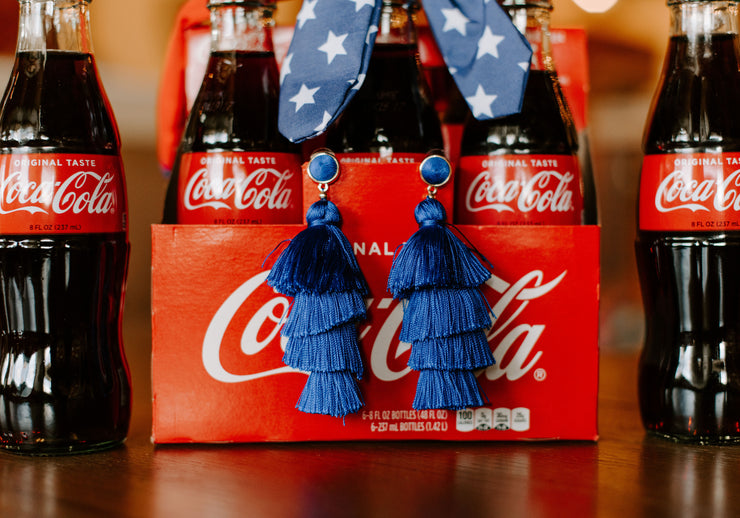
210, 2, 274, 52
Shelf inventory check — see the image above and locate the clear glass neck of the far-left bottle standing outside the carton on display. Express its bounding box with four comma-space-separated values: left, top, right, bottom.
17, 0, 92, 54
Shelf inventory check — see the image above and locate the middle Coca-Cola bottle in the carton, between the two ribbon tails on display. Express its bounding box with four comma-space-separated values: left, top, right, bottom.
325, 1, 443, 163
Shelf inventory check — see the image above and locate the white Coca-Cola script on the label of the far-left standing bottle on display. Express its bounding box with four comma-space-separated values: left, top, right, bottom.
0, 171, 118, 215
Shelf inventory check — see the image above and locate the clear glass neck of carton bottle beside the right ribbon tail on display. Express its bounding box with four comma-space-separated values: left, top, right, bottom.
503, 2, 555, 72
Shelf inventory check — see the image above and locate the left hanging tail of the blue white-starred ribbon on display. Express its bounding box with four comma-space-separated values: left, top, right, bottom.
278, 0, 382, 142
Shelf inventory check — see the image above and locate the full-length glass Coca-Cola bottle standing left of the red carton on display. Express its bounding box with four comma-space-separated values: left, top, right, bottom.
0, 0, 131, 455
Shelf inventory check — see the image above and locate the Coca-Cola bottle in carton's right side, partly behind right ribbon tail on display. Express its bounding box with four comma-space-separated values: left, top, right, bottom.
455, 0, 596, 225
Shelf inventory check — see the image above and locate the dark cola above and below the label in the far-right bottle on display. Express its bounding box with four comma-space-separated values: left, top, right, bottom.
636, 35, 740, 442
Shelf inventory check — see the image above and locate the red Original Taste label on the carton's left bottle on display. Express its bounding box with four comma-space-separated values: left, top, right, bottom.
177, 152, 303, 225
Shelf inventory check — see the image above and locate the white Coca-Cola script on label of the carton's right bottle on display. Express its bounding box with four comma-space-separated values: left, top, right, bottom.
465, 171, 579, 213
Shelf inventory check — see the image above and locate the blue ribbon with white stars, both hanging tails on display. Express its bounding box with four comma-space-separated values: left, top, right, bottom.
278, 0, 532, 142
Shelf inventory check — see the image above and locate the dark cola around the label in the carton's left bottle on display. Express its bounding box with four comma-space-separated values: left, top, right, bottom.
163, 51, 300, 223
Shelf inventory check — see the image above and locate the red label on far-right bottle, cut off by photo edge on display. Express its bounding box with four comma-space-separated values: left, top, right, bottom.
639, 153, 740, 231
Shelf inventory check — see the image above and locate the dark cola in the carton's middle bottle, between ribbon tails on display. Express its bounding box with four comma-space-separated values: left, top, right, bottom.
326, 44, 443, 154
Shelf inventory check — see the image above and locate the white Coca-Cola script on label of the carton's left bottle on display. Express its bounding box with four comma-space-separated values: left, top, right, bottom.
183, 167, 293, 210
